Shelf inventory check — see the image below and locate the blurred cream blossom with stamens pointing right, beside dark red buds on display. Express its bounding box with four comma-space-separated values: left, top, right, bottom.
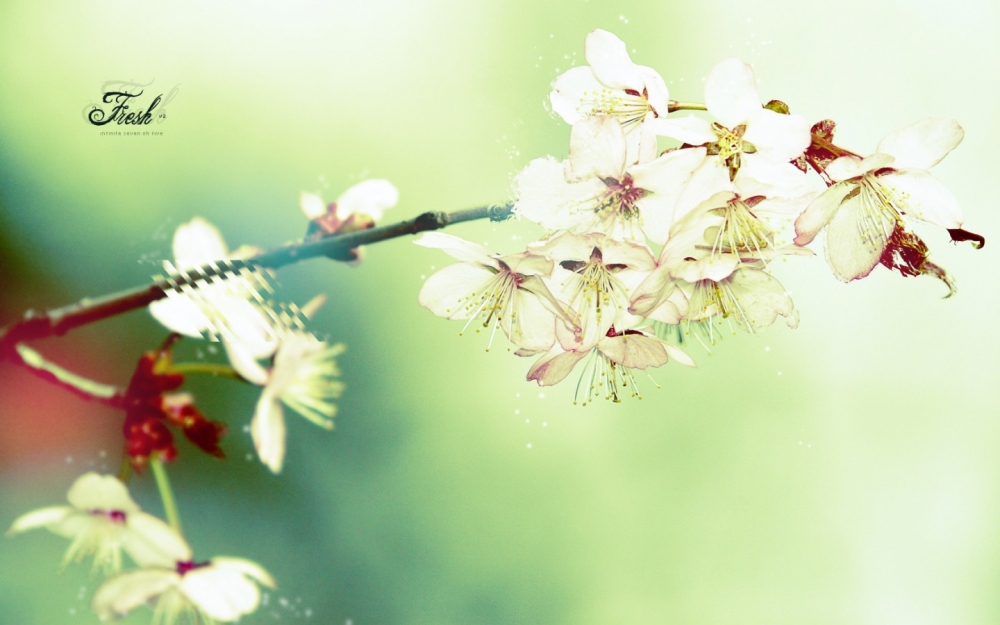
232, 332, 345, 473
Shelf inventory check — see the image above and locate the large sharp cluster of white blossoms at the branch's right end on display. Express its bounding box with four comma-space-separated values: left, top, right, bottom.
416, 30, 976, 403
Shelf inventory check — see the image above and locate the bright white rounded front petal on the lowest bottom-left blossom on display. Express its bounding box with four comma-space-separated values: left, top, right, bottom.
180, 560, 260, 622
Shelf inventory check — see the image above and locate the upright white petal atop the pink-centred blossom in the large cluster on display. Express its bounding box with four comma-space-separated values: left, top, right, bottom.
566, 115, 628, 182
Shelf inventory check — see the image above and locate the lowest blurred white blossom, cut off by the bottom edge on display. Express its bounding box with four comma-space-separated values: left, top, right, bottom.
92, 552, 275, 625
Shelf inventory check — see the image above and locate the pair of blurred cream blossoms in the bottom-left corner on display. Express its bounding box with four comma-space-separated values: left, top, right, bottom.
7, 472, 275, 625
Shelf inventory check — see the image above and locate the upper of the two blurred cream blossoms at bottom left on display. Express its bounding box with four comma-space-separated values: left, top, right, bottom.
7, 472, 184, 574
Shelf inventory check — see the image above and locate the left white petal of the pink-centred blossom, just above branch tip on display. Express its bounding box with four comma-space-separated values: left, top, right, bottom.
514, 158, 607, 230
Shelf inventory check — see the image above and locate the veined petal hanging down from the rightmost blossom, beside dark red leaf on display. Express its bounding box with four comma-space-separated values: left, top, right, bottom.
820, 194, 896, 282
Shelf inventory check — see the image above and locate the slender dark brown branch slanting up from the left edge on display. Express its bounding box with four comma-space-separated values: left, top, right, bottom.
0, 204, 513, 346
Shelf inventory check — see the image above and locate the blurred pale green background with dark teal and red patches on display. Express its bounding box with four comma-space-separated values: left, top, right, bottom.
0, 0, 1000, 625
